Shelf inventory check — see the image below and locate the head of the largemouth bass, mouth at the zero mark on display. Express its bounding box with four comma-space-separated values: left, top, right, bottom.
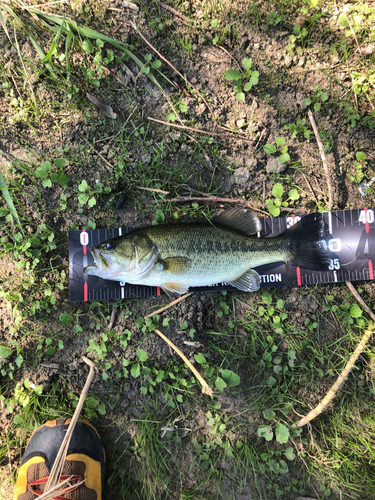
83, 233, 157, 283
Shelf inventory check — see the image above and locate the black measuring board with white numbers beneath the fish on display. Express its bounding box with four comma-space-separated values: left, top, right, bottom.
69, 208, 375, 302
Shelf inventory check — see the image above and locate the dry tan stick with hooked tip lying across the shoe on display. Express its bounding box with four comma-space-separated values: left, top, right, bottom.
45, 356, 95, 493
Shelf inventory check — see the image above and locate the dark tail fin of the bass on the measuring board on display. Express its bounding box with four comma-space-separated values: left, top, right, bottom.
283, 213, 330, 271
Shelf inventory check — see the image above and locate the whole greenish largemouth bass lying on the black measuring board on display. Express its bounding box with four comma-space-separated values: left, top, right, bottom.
83, 208, 329, 296
